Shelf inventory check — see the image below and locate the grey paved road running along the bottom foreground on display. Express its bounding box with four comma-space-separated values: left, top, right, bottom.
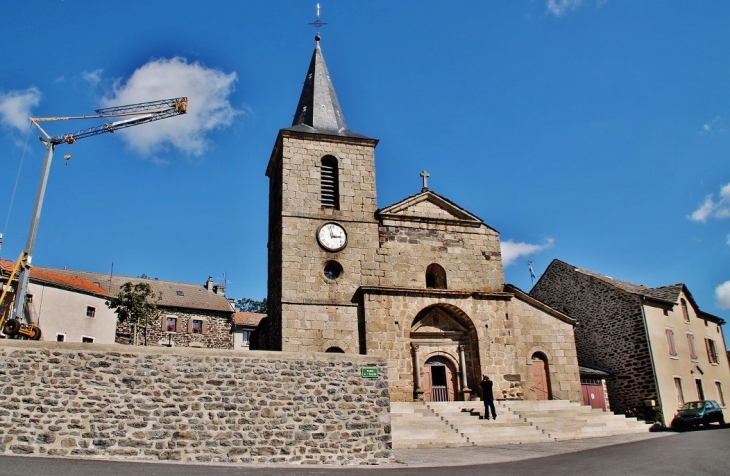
0, 427, 730, 476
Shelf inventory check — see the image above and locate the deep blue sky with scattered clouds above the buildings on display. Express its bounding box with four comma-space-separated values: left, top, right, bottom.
0, 0, 730, 330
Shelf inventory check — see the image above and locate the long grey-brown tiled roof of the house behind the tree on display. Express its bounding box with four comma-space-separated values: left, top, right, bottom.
44, 269, 233, 315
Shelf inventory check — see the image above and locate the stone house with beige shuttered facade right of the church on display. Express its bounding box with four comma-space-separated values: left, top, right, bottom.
530, 259, 730, 423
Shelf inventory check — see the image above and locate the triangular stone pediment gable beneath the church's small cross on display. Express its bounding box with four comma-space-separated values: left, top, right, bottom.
375, 189, 496, 231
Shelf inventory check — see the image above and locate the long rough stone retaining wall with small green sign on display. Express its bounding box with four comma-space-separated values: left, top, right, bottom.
0, 340, 392, 464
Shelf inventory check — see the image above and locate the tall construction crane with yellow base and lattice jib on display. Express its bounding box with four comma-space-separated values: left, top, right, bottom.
0, 97, 188, 340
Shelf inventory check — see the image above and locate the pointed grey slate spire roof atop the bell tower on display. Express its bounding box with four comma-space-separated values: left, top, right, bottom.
285, 36, 365, 138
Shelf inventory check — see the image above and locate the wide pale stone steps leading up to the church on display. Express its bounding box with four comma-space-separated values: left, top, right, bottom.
390, 400, 650, 449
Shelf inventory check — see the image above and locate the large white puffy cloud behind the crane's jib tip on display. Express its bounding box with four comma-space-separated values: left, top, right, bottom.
103, 57, 242, 156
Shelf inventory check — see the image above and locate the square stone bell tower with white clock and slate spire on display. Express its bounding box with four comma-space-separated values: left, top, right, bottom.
263, 35, 378, 353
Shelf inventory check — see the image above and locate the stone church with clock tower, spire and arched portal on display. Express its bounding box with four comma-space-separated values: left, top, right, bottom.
257, 36, 582, 402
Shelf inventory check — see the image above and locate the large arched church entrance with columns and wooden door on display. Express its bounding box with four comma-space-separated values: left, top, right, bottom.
410, 304, 480, 402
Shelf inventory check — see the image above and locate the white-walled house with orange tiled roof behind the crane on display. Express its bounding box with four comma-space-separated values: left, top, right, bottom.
0, 260, 117, 344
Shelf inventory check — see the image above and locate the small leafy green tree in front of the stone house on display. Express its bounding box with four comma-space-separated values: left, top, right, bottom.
106, 282, 162, 345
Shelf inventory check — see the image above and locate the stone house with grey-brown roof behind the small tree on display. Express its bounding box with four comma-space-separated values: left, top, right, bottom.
54, 269, 233, 349
